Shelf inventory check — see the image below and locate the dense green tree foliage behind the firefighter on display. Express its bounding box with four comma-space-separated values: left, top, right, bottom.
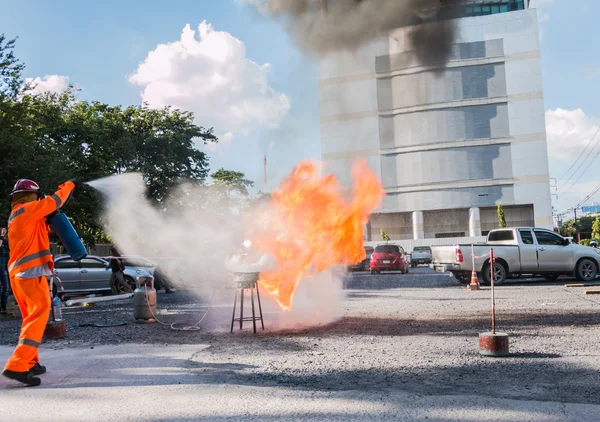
0, 35, 223, 244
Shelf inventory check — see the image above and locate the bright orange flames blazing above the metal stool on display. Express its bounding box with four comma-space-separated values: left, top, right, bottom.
249, 160, 384, 310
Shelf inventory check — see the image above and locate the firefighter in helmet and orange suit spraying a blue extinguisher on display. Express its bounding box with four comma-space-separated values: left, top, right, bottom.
2, 179, 81, 386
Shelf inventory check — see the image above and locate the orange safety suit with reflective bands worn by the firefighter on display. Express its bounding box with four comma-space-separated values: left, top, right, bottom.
4, 182, 75, 372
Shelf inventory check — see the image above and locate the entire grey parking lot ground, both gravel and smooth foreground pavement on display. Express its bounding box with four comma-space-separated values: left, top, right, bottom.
0, 268, 600, 421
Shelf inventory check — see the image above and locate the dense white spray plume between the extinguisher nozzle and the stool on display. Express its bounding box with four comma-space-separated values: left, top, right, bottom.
89, 173, 243, 295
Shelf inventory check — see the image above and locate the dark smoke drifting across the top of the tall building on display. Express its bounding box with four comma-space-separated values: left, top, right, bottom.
264, 0, 460, 66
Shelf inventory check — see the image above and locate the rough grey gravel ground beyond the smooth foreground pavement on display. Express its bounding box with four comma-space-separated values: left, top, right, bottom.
0, 268, 600, 404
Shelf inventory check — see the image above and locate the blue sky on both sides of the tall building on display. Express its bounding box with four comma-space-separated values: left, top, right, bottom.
0, 0, 600, 219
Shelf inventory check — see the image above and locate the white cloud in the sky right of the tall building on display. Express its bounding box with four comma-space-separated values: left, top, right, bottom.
546, 108, 600, 162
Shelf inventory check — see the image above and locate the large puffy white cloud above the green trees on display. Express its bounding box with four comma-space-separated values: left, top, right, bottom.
129, 21, 290, 142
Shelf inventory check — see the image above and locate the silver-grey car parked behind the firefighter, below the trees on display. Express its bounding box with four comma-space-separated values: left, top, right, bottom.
54, 255, 154, 294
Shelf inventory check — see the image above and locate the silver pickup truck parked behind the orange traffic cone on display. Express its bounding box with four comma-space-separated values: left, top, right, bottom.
430, 227, 600, 284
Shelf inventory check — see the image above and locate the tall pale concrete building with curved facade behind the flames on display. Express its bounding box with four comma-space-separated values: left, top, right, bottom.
319, 0, 553, 240
